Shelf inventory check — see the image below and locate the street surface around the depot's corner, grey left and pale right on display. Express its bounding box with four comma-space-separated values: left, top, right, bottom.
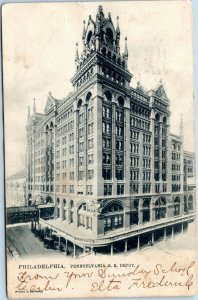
7, 222, 196, 257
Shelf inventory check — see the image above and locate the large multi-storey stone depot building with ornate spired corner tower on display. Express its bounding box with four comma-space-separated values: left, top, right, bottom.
26, 6, 195, 253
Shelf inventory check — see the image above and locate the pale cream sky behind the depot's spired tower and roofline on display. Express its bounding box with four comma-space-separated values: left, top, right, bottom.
2, 1, 195, 176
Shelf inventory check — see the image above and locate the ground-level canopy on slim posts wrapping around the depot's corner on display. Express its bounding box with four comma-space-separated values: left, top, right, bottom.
31, 215, 194, 258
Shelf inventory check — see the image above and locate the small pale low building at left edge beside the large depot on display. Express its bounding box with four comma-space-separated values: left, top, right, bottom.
6, 169, 27, 207
